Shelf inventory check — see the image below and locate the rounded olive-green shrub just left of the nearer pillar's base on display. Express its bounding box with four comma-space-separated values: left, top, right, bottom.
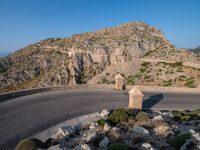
108, 108, 129, 124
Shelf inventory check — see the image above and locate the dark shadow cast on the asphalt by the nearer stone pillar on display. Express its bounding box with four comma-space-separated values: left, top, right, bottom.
142, 94, 164, 109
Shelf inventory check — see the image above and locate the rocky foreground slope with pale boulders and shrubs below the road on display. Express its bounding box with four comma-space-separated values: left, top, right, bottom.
16, 108, 200, 150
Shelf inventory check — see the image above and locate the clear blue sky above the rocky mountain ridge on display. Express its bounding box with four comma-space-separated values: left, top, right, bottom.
0, 0, 200, 52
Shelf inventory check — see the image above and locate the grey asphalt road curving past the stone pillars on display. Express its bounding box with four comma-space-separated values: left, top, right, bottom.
0, 89, 200, 150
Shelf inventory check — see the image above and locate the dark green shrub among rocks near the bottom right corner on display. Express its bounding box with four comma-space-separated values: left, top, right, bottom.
168, 133, 192, 149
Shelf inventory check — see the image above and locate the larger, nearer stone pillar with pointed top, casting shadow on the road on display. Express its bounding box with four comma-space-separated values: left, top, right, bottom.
128, 87, 144, 109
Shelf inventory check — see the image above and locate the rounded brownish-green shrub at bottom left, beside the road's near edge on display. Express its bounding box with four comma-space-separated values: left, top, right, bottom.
16, 138, 48, 150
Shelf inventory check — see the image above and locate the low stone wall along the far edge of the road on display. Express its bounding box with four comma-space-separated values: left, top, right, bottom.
0, 84, 200, 102
